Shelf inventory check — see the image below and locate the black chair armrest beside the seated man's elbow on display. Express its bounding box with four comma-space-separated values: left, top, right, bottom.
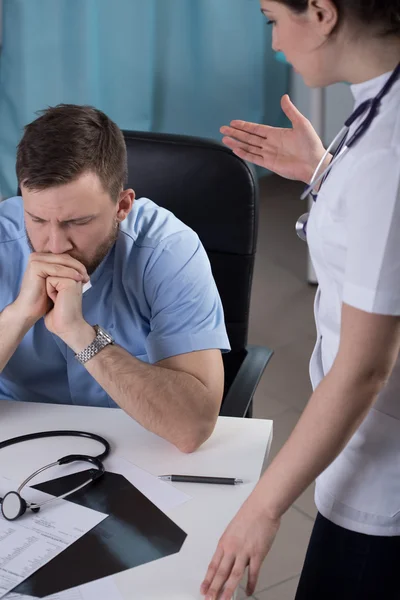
220, 346, 273, 417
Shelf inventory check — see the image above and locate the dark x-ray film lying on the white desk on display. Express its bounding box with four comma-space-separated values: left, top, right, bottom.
13, 471, 186, 598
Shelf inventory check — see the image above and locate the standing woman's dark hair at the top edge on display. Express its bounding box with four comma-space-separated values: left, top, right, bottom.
278, 0, 400, 36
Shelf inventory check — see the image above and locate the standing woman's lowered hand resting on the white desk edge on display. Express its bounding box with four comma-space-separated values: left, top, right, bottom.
201, 496, 280, 600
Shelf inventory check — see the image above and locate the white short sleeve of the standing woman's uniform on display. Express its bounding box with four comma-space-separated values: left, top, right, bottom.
343, 148, 400, 315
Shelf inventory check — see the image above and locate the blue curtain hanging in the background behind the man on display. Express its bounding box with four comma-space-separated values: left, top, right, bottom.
0, 0, 287, 196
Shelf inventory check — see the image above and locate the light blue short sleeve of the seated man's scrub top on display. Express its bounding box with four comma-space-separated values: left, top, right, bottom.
144, 230, 230, 363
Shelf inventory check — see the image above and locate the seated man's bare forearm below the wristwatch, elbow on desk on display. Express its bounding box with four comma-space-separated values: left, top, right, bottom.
69, 326, 218, 452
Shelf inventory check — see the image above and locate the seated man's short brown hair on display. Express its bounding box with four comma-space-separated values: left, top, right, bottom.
16, 104, 128, 201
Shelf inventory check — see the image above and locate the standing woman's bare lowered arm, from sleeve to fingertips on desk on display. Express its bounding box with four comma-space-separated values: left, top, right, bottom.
202, 304, 400, 600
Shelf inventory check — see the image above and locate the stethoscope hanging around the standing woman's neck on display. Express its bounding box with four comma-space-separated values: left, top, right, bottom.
296, 63, 400, 242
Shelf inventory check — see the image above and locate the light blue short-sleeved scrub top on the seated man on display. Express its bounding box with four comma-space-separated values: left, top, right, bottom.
0, 197, 230, 407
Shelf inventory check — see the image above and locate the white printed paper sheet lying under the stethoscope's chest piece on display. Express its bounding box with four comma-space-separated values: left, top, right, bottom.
0, 476, 107, 598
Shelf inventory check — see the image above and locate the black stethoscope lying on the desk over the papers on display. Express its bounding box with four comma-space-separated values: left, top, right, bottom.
0, 431, 110, 521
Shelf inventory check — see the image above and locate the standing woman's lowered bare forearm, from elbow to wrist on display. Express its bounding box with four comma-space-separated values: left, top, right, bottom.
255, 372, 380, 518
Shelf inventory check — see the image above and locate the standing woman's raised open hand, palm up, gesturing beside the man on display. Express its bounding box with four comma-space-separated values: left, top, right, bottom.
220, 95, 330, 183
